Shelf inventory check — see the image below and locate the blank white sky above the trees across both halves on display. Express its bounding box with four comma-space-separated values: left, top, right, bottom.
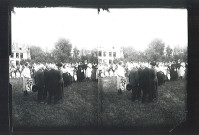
11, 8, 188, 51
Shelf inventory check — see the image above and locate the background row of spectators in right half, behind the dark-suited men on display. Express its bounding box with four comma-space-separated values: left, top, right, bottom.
98, 62, 186, 80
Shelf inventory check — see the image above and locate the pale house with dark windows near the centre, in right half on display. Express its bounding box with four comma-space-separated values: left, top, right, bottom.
98, 46, 124, 64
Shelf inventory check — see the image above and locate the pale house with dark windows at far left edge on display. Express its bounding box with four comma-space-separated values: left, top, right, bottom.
9, 43, 31, 66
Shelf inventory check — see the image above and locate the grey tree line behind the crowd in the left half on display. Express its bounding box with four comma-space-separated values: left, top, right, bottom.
21, 38, 97, 64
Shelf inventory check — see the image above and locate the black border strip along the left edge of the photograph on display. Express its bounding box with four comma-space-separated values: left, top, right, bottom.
0, 1, 9, 132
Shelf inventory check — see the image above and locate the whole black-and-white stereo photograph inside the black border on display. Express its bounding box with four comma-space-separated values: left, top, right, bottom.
9, 7, 188, 130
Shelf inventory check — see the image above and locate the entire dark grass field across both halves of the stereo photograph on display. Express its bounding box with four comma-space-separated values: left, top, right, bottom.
10, 79, 186, 131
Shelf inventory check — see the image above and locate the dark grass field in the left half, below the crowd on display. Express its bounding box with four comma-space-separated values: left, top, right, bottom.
10, 79, 98, 128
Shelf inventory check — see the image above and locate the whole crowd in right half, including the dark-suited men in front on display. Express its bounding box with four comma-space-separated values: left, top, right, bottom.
98, 61, 187, 102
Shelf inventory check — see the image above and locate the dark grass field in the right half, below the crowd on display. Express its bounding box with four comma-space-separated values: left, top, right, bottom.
100, 77, 186, 129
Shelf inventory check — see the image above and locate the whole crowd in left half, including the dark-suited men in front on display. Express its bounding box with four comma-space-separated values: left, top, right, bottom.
10, 62, 98, 104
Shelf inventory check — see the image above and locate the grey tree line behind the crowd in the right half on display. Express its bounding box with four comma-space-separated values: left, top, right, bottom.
123, 39, 187, 63
